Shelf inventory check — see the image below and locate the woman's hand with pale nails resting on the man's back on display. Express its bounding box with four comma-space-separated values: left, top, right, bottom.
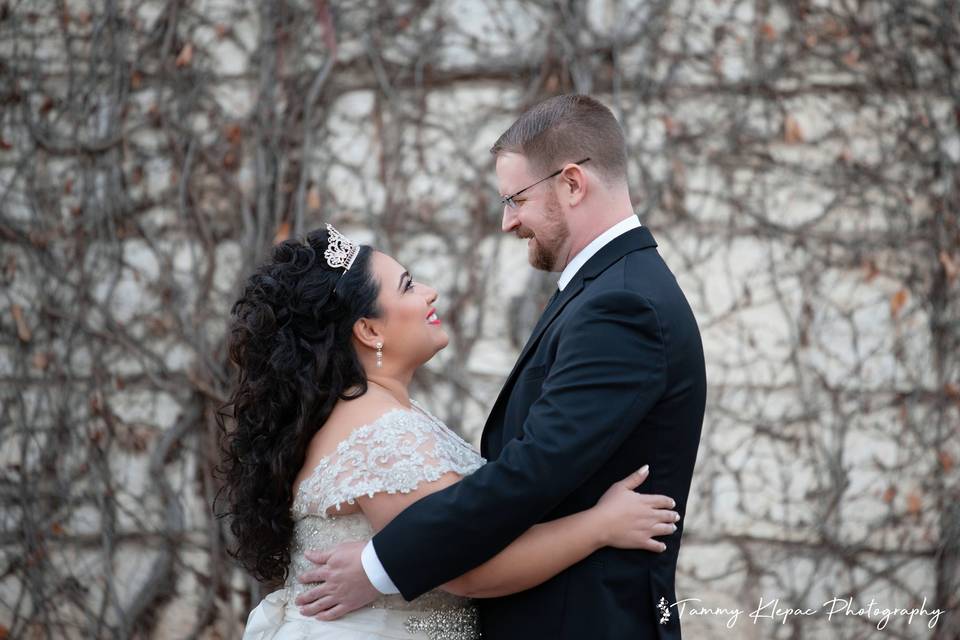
594, 465, 680, 553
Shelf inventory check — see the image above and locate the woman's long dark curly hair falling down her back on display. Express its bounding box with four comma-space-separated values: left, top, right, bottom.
215, 229, 381, 583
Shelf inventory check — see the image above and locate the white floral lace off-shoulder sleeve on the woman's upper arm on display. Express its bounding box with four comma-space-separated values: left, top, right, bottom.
294, 409, 485, 517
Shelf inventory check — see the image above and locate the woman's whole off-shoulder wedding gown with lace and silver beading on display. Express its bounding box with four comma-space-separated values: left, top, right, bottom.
243, 403, 485, 640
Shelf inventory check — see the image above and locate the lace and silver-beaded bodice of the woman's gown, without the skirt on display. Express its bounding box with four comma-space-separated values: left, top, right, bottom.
286, 402, 485, 639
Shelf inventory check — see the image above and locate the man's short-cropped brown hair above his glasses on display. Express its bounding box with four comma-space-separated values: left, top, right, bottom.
490, 95, 627, 184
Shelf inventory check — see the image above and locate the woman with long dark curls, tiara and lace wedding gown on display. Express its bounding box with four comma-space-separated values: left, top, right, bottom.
222, 225, 679, 640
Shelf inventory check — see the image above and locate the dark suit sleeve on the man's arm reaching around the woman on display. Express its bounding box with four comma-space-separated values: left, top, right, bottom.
373, 291, 667, 600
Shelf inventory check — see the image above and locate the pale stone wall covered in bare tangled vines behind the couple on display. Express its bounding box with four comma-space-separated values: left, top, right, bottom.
0, 0, 960, 638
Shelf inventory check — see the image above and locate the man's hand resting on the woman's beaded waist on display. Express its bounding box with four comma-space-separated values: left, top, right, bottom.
295, 542, 380, 620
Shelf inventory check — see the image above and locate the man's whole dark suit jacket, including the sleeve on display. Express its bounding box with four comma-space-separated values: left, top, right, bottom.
374, 227, 706, 640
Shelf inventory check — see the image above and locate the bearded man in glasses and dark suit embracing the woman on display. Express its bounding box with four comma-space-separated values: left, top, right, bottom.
297, 95, 706, 640
